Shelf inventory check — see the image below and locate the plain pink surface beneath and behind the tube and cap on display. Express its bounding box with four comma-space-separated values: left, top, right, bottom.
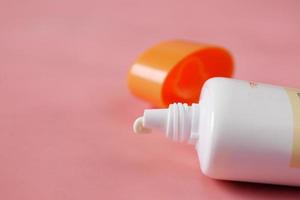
0, 0, 300, 200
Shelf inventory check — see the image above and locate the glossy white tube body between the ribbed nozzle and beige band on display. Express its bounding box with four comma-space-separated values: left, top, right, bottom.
196, 78, 300, 186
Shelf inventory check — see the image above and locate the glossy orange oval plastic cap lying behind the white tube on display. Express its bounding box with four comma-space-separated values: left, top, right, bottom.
128, 40, 233, 107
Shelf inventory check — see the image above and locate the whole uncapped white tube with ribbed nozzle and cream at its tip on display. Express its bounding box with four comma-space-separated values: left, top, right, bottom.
134, 78, 300, 186
